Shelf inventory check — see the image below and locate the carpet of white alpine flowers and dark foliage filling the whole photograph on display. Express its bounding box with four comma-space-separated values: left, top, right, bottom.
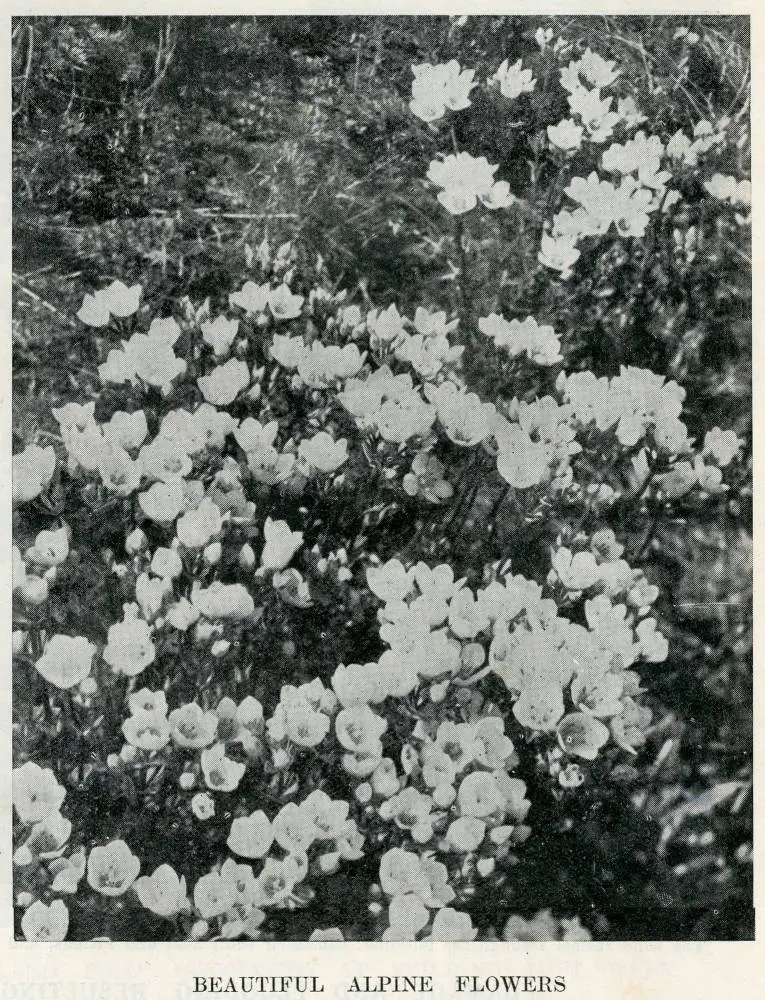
13, 18, 751, 941
